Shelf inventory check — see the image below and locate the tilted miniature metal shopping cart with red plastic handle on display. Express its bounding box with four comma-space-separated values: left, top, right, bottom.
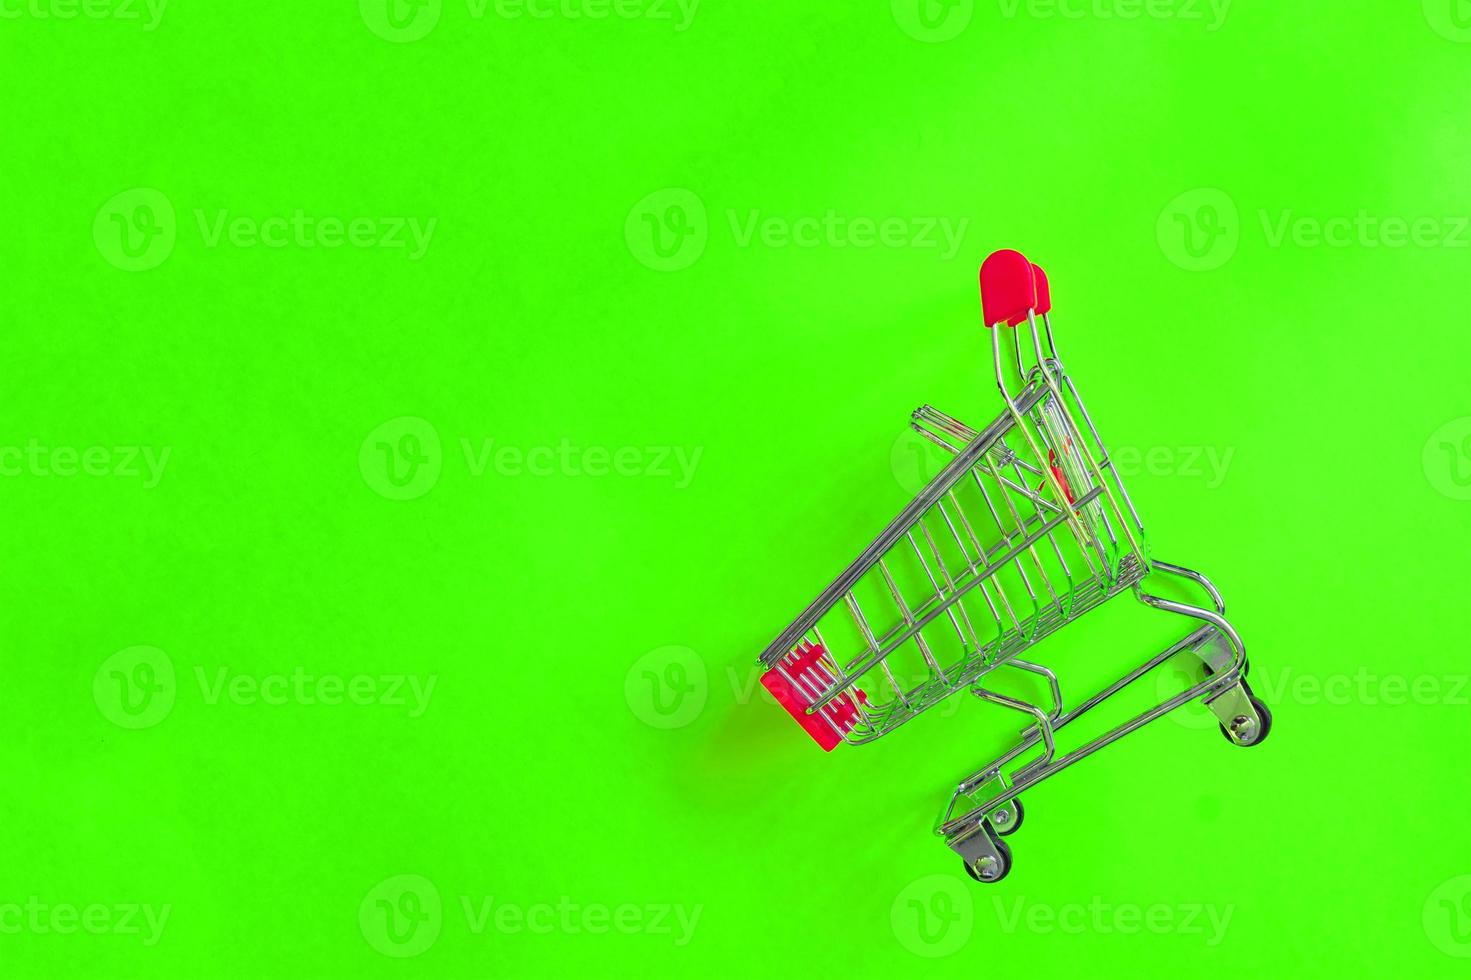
761, 250, 1271, 881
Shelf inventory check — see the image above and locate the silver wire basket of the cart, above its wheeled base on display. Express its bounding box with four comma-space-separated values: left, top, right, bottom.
761, 315, 1150, 743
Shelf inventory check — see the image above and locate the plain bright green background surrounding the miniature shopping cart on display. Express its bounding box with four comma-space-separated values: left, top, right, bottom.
0, 0, 1471, 977
